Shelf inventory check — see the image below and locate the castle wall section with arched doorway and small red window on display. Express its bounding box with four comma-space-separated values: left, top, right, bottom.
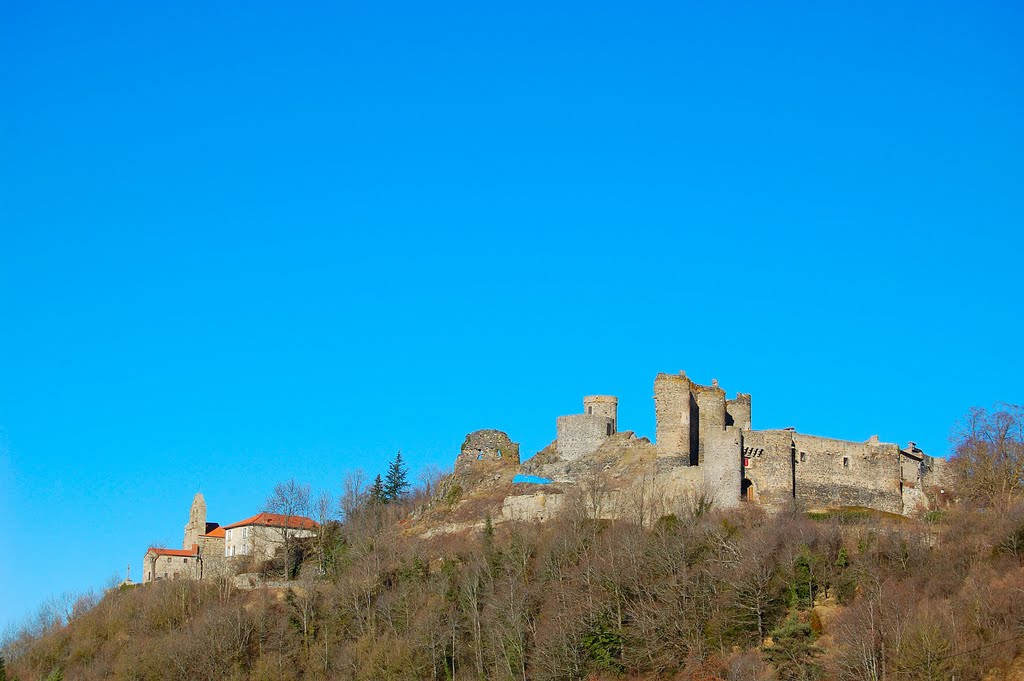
741, 430, 794, 511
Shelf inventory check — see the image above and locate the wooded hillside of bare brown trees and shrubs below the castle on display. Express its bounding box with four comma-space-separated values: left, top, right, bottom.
8, 405, 1024, 681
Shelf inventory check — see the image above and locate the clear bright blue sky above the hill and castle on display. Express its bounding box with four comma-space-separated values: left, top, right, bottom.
0, 0, 1024, 626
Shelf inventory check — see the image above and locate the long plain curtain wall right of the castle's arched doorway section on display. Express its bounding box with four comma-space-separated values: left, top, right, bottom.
794, 433, 903, 513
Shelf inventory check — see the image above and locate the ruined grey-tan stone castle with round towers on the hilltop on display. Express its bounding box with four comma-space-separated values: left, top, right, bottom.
456, 372, 944, 518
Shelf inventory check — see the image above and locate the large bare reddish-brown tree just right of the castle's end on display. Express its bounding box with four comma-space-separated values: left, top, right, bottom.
952, 403, 1024, 506
